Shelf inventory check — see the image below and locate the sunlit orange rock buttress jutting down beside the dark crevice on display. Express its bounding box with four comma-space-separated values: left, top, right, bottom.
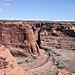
24, 24, 39, 54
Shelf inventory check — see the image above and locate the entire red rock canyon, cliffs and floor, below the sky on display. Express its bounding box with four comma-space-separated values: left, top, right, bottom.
0, 20, 75, 75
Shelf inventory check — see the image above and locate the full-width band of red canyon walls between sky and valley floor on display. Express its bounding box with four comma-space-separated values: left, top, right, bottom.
0, 21, 75, 51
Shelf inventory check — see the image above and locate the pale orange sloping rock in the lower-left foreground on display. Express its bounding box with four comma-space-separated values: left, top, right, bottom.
0, 45, 26, 75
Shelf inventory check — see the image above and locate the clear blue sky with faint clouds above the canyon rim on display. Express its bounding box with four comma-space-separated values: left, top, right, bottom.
0, 0, 75, 21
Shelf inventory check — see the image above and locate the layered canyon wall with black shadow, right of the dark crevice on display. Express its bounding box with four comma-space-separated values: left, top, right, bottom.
34, 22, 75, 50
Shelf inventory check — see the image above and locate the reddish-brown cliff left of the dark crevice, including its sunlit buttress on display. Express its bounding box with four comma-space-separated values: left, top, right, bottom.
0, 21, 39, 55
